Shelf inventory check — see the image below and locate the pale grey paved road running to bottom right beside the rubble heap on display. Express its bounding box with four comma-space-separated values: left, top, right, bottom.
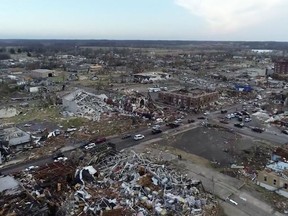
178, 160, 282, 216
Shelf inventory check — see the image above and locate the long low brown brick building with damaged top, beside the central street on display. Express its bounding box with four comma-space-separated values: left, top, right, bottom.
158, 90, 219, 109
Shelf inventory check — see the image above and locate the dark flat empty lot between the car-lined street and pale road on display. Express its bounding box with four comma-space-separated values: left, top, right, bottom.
159, 127, 255, 166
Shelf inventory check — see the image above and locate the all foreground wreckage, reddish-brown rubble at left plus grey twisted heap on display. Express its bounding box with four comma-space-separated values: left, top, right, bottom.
0, 152, 217, 216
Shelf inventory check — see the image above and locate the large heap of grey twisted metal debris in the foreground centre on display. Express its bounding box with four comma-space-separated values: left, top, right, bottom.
74, 153, 212, 215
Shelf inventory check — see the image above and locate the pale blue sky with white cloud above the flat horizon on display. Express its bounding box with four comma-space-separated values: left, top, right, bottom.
0, 0, 288, 41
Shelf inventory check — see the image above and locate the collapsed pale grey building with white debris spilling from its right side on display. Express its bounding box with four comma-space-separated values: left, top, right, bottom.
62, 89, 112, 121
